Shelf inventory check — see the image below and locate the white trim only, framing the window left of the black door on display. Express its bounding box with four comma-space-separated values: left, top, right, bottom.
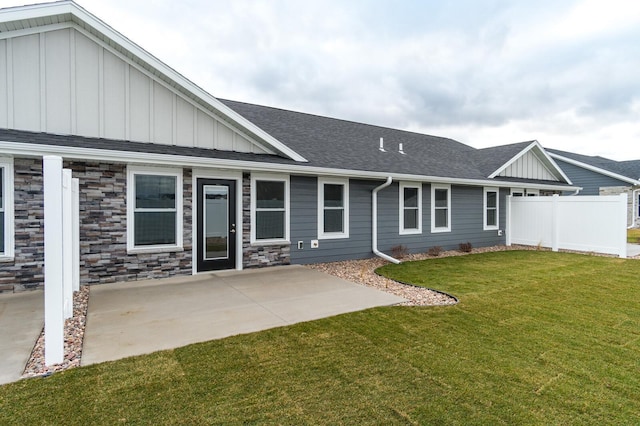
127, 165, 184, 254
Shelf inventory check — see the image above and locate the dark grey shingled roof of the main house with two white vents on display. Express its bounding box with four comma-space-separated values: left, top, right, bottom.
0, 99, 566, 186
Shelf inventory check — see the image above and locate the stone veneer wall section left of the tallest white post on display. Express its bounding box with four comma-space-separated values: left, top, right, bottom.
0, 158, 44, 293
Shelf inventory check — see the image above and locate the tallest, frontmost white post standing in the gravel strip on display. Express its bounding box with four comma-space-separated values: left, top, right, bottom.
42, 156, 64, 365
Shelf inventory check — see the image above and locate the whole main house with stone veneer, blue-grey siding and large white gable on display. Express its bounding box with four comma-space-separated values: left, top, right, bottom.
0, 1, 578, 291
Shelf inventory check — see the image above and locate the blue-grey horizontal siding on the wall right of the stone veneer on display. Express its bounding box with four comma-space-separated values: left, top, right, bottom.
291, 176, 509, 264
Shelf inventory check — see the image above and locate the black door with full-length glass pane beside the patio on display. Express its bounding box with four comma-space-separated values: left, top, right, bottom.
196, 179, 236, 272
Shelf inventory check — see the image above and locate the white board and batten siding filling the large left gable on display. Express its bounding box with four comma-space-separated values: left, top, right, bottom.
0, 27, 272, 153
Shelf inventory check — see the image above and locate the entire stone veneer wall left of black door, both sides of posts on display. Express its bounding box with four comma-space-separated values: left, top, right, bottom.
0, 158, 192, 293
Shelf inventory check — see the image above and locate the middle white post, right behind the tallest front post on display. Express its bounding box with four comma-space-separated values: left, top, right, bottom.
62, 169, 73, 319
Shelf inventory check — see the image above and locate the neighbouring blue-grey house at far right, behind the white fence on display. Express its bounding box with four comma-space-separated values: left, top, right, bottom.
547, 149, 640, 226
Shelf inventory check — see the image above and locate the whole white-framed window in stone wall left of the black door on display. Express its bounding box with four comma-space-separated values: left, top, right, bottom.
127, 167, 182, 251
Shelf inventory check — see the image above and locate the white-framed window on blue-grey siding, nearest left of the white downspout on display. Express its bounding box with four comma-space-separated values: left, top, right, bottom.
318, 178, 349, 239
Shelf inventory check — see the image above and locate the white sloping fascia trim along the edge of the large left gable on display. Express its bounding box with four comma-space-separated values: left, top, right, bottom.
0, 1, 307, 162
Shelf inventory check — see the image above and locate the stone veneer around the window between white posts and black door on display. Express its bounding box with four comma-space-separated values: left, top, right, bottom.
64, 161, 192, 284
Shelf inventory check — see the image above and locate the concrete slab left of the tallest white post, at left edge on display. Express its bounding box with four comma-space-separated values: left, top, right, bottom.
0, 290, 44, 385
